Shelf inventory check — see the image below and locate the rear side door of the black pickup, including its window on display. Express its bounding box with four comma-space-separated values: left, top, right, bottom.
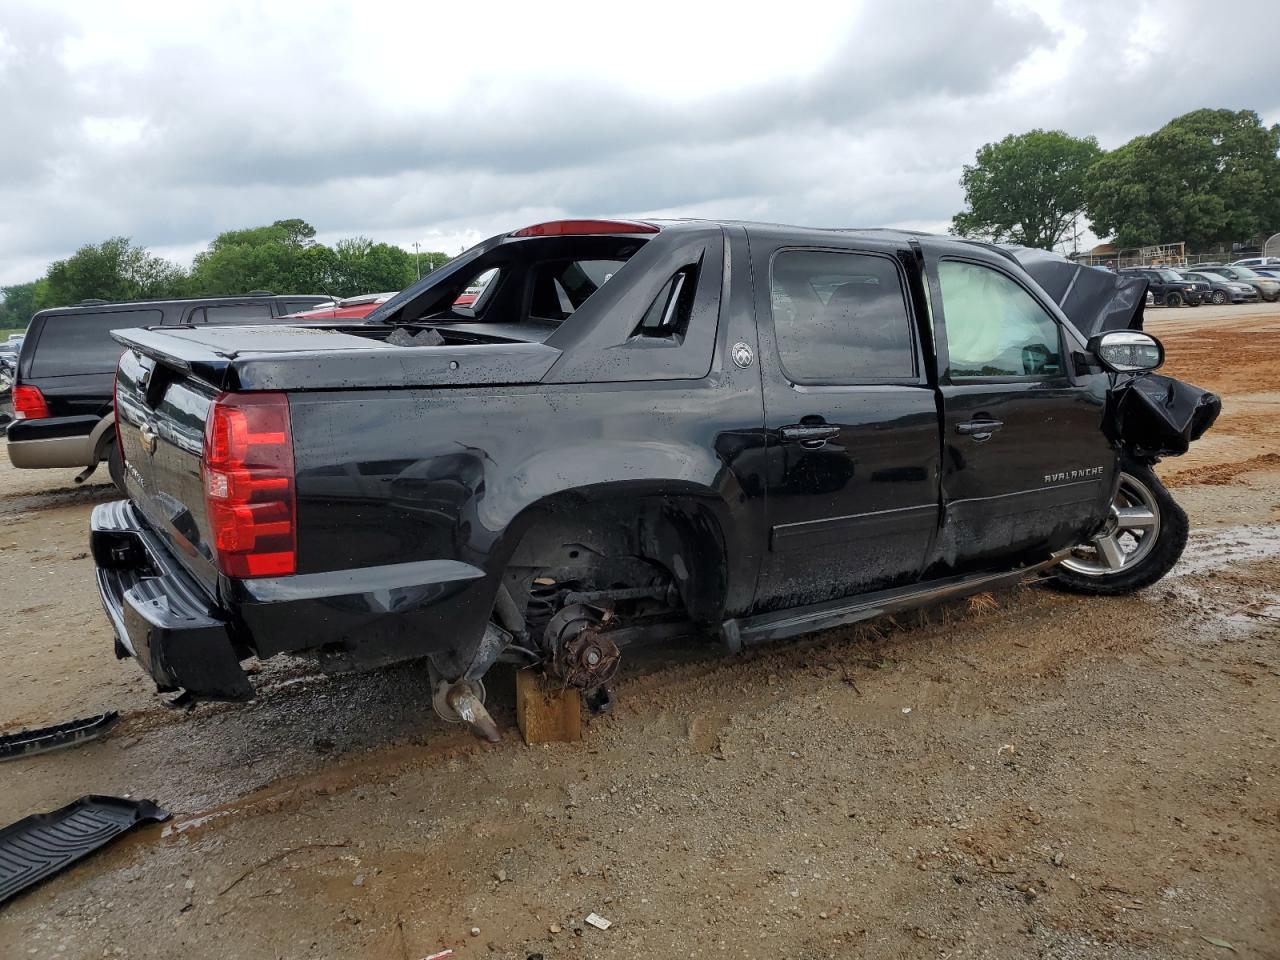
751, 244, 938, 609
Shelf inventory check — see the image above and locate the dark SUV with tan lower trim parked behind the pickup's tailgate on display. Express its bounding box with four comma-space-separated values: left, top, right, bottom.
8, 293, 329, 483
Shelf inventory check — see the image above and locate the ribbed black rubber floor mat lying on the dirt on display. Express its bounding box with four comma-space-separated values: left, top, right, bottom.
0, 796, 169, 904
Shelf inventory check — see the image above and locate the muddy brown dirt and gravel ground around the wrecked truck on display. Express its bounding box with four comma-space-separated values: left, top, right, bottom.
0, 305, 1280, 960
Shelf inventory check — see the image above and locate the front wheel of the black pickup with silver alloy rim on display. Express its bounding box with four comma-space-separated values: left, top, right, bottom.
1053, 458, 1190, 596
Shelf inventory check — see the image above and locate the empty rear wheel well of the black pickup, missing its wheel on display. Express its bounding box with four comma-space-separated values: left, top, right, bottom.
503, 494, 727, 623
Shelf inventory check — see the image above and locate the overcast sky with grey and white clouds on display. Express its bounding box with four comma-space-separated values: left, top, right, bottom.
0, 0, 1280, 283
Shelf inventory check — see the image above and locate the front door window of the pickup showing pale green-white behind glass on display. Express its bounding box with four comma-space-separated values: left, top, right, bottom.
938, 260, 1062, 380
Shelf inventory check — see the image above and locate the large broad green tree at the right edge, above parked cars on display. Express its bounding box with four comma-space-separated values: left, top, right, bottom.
1087, 109, 1280, 248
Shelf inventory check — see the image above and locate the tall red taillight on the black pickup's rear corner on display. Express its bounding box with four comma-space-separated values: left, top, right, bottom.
201, 393, 298, 577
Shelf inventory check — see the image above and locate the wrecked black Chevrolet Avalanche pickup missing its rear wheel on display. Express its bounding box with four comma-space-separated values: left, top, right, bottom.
92, 220, 1220, 736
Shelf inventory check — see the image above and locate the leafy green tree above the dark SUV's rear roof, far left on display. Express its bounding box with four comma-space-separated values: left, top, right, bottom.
36, 237, 186, 308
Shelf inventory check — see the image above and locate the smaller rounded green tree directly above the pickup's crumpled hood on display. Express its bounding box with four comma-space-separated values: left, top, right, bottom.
951, 129, 1102, 250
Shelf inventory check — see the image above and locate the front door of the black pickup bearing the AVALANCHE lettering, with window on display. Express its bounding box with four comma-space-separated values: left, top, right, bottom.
924, 242, 1119, 573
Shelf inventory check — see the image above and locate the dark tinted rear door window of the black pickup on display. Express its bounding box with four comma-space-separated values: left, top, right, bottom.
771, 250, 916, 383
